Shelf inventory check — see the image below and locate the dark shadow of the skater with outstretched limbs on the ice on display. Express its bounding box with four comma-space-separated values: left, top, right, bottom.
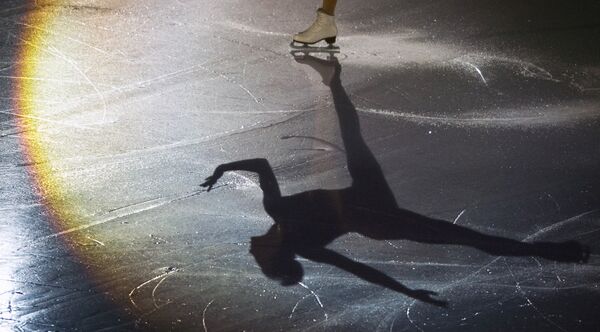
202, 55, 589, 306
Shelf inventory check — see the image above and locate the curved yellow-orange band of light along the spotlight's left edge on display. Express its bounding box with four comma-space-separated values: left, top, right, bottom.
12, 1, 82, 241
